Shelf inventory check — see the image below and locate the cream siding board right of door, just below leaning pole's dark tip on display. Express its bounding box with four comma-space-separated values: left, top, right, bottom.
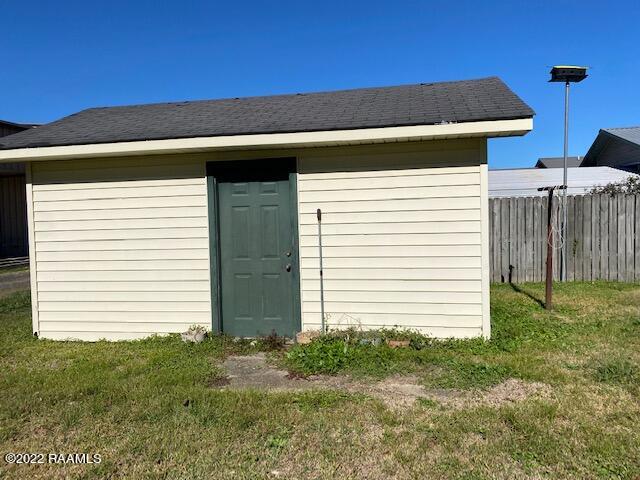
300, 221, 480, 237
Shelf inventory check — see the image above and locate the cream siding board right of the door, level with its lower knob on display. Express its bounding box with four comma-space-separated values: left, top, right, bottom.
300, 268, 481, 280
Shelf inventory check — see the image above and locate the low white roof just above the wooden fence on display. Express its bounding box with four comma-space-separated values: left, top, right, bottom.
489, 167, 636, 198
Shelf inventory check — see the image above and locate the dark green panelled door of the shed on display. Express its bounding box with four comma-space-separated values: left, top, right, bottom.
216, 160, 298, 337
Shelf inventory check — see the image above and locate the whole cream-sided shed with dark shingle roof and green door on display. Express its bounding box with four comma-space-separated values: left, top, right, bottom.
0, 77, 533, 340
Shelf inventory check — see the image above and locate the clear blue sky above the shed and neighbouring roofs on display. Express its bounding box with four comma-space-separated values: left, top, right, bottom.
0, 0, 640, 168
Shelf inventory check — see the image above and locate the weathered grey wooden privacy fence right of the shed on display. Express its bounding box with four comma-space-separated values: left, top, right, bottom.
489, 194, 640, 282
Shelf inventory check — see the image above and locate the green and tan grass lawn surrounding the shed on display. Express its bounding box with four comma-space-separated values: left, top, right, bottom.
0, 283, 640, 479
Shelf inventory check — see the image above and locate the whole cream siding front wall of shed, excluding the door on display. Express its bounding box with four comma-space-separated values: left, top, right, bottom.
27, 139, 489, 340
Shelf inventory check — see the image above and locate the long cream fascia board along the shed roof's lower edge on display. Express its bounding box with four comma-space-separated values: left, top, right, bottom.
0, 117, 533, 163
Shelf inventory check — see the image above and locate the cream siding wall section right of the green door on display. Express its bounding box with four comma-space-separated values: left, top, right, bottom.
298, 140, 488, 337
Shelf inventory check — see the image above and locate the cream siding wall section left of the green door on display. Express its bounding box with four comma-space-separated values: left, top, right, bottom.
29, 157, 211, 340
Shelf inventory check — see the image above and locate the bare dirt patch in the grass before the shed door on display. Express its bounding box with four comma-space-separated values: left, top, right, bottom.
215, 352, 550, 409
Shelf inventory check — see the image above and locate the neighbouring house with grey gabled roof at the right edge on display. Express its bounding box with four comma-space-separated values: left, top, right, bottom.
581, 127, 640, 172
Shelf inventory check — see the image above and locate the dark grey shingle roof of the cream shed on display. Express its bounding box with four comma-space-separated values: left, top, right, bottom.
0, 77, 534, 149
